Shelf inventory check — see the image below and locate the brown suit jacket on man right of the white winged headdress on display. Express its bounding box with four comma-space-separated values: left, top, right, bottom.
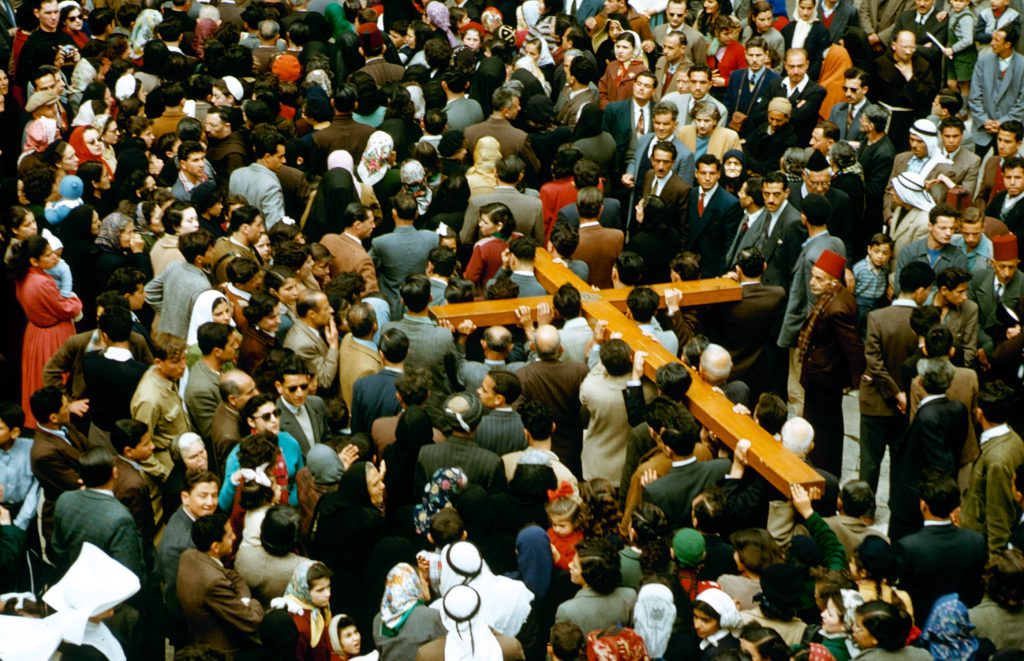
177, 548, 263, 652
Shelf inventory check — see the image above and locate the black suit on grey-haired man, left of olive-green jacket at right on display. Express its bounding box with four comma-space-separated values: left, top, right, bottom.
889, 395, 966, 540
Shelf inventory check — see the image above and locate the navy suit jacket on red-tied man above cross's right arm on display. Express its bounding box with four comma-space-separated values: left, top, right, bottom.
686, 184, 743, 277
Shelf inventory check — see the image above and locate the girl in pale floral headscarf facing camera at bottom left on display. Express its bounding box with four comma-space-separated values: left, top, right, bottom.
284, 560, 333, 659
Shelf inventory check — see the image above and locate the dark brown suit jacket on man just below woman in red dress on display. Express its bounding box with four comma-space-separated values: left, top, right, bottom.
30, 425, 90, 539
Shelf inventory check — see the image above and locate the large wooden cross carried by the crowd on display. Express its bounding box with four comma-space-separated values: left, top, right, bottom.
431, 249, 824, 496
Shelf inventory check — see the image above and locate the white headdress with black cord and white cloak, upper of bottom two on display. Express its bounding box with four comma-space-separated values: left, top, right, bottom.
431, 541, 534, 636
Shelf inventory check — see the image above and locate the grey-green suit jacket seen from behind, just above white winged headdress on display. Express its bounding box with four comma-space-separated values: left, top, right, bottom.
47, 489, 146, 579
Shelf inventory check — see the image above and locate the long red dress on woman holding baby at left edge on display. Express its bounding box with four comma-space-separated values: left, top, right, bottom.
14, 266, 82, 428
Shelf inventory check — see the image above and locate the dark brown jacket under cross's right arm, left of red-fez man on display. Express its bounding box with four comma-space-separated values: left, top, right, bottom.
700, 282, 785, 401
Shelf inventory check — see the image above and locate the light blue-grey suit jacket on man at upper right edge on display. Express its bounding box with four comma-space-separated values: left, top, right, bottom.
968, 51, 1024, 145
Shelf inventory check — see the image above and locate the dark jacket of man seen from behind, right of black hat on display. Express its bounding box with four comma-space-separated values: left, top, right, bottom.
895, 524, 986, 622
